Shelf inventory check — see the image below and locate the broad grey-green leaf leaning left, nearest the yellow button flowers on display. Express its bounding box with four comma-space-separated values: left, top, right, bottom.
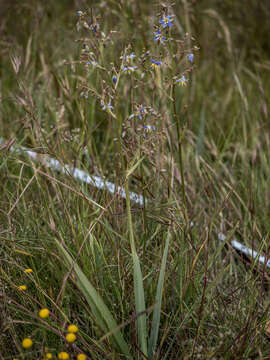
55, 239, 131, 359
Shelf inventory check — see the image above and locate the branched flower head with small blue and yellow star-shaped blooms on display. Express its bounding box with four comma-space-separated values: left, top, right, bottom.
77, 7, 198, 167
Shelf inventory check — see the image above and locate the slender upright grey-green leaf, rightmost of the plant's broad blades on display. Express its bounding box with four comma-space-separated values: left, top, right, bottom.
148, 232, 171, 359
